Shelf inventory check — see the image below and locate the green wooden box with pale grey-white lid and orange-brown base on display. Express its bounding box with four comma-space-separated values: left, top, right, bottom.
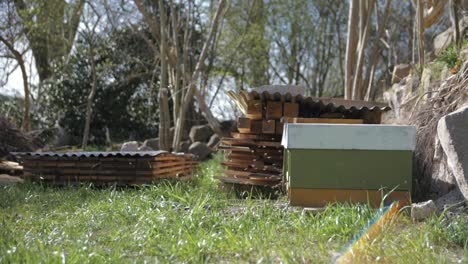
282, 124, 416, 207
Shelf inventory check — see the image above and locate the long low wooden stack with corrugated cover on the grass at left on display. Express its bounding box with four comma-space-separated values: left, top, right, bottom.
15, 151, 198, 185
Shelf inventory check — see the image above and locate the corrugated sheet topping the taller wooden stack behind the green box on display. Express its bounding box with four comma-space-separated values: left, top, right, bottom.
240, 91, 391, 111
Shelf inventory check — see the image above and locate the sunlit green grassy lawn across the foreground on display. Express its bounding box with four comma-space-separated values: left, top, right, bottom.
0, 155, 468, 263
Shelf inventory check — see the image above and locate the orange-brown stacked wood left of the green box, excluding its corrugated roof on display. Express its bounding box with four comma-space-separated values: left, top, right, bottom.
218, 93, 292, 187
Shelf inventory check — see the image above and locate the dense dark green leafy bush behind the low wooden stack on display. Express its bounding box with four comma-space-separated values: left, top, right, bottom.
39, 28, 157, 145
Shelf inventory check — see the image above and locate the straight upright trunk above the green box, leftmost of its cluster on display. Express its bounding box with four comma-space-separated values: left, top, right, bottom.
344, 0, 359, 99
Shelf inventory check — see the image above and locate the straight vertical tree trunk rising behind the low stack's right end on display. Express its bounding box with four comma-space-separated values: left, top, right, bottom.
158, 0, 171, 150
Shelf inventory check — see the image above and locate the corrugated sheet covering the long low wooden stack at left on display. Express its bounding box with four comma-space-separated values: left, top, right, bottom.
11, 150, 175, 158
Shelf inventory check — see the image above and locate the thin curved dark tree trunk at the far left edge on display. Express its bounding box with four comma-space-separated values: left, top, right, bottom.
0, 35, 31, 132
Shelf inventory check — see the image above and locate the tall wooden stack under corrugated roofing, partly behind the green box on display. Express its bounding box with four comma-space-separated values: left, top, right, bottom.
216, 87, 389, 191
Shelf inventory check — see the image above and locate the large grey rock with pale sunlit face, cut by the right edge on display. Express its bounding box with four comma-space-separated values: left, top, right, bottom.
437, 106, 468, 200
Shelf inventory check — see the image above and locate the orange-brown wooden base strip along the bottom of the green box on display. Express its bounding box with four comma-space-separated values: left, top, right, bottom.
288, 188, 410, 207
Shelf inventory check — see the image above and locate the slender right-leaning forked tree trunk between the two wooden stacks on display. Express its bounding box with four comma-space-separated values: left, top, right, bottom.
173, 0, 227, 150
